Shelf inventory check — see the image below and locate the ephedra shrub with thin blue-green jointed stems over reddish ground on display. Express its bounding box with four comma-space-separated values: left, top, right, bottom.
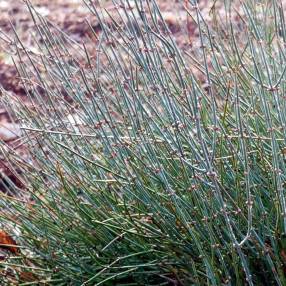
0, 0, 286, 285
